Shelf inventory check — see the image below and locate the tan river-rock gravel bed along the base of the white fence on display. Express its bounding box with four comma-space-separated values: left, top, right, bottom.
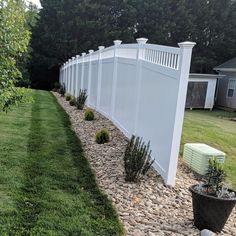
53, 93, 236, 236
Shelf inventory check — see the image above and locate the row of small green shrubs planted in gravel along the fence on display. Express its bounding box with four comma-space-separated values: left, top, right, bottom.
58, 85, 154, 182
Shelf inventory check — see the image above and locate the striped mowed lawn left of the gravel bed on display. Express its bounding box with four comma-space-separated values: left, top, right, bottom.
0, 91, 123, 236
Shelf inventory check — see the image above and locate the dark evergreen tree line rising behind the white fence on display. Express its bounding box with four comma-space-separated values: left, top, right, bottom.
30, 0, 236, 89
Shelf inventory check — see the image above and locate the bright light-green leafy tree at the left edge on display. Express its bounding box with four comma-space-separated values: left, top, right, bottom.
0, 0, 30, 111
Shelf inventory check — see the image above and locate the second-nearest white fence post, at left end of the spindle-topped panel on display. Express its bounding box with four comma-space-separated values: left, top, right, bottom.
133, 38, 148, 135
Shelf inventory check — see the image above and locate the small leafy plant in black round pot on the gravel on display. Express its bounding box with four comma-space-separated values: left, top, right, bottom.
189, 158, 236, 233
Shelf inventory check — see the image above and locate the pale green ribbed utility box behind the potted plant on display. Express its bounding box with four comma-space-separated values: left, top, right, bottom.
184, 143, 225, 175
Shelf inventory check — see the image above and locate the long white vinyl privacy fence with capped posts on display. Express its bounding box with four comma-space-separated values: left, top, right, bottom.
60, 38, 195, 186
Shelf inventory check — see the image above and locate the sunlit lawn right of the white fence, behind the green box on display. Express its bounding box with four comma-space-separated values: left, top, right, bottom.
181, 110, 236, 188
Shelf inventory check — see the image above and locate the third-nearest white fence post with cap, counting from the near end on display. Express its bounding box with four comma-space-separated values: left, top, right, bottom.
110, 40, 122, 120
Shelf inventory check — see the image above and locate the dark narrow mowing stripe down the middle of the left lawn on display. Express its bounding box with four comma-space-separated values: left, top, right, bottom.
14, 92, 44, 235
